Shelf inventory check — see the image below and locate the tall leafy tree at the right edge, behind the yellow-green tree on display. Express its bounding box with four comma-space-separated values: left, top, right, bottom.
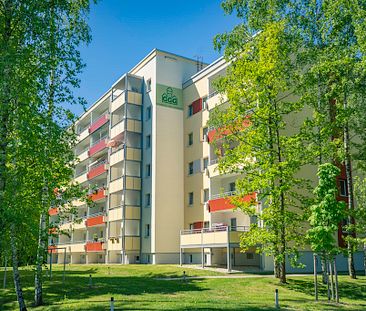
216, 0, 366, 277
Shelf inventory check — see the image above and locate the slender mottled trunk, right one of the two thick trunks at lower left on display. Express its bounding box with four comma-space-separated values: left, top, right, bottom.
34, 213, 46, 307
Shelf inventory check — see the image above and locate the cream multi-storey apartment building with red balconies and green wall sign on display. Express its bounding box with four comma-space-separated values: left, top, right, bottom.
49, 49, 362, 271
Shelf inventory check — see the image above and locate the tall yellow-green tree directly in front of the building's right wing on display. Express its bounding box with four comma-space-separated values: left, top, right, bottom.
209, 22, 306, 283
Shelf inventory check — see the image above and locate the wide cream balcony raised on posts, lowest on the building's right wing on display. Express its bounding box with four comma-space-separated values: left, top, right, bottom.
180, 226, 249, 248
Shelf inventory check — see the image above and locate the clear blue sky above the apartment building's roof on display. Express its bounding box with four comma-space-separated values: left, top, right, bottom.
73, 0, 238, 114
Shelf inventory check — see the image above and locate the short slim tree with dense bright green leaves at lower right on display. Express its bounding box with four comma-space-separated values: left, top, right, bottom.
307, 163, 345, 297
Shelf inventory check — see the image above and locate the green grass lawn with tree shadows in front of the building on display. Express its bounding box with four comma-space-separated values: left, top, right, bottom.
0, 265, 366, 311
